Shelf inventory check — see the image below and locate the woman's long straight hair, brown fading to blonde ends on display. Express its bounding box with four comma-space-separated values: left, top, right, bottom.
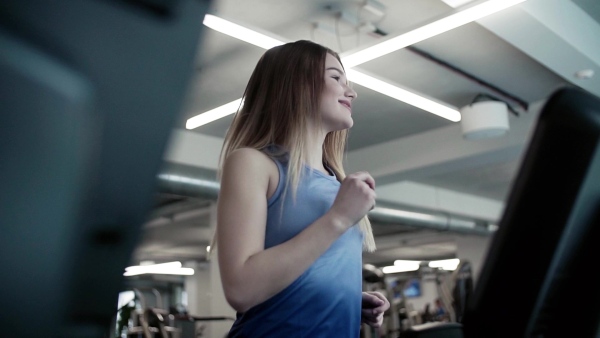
220, 40, 375, 251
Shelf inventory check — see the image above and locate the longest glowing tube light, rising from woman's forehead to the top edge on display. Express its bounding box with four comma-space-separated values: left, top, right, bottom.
342, 0, 525, 68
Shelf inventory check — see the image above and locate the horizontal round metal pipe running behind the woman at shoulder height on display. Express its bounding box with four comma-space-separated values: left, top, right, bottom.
158, 162, 493, 236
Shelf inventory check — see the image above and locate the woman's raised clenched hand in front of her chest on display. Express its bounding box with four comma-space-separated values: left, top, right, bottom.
330, 171, 376, 230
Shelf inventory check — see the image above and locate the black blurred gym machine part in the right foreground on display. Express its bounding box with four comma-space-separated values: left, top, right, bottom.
400, 89, 600, 338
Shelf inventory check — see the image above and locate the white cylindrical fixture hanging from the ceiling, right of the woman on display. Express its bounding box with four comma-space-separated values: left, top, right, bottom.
460, 101, 509, 140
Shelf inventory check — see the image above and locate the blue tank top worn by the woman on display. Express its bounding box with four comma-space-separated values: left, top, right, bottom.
228, 148, 363, 338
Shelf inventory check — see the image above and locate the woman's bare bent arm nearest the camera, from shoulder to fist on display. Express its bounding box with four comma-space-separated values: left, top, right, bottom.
217, 149, 375, 312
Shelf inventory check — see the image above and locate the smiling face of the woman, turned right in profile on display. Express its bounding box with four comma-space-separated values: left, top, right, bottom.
319, 53, 356, 132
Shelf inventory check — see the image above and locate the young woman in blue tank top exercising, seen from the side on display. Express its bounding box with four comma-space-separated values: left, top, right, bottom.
216, 41, 389, 337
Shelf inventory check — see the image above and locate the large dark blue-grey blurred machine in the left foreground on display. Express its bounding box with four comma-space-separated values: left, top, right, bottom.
0, 0, 208, 337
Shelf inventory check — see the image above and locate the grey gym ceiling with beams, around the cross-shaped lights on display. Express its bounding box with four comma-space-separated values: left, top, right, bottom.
129, 0, 600, 270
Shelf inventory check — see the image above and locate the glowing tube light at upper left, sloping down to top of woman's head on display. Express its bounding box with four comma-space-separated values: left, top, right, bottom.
202, 14, 284, 49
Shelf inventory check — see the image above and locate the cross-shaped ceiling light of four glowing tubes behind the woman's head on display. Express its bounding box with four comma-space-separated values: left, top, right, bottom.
186, 0, 525, 129
